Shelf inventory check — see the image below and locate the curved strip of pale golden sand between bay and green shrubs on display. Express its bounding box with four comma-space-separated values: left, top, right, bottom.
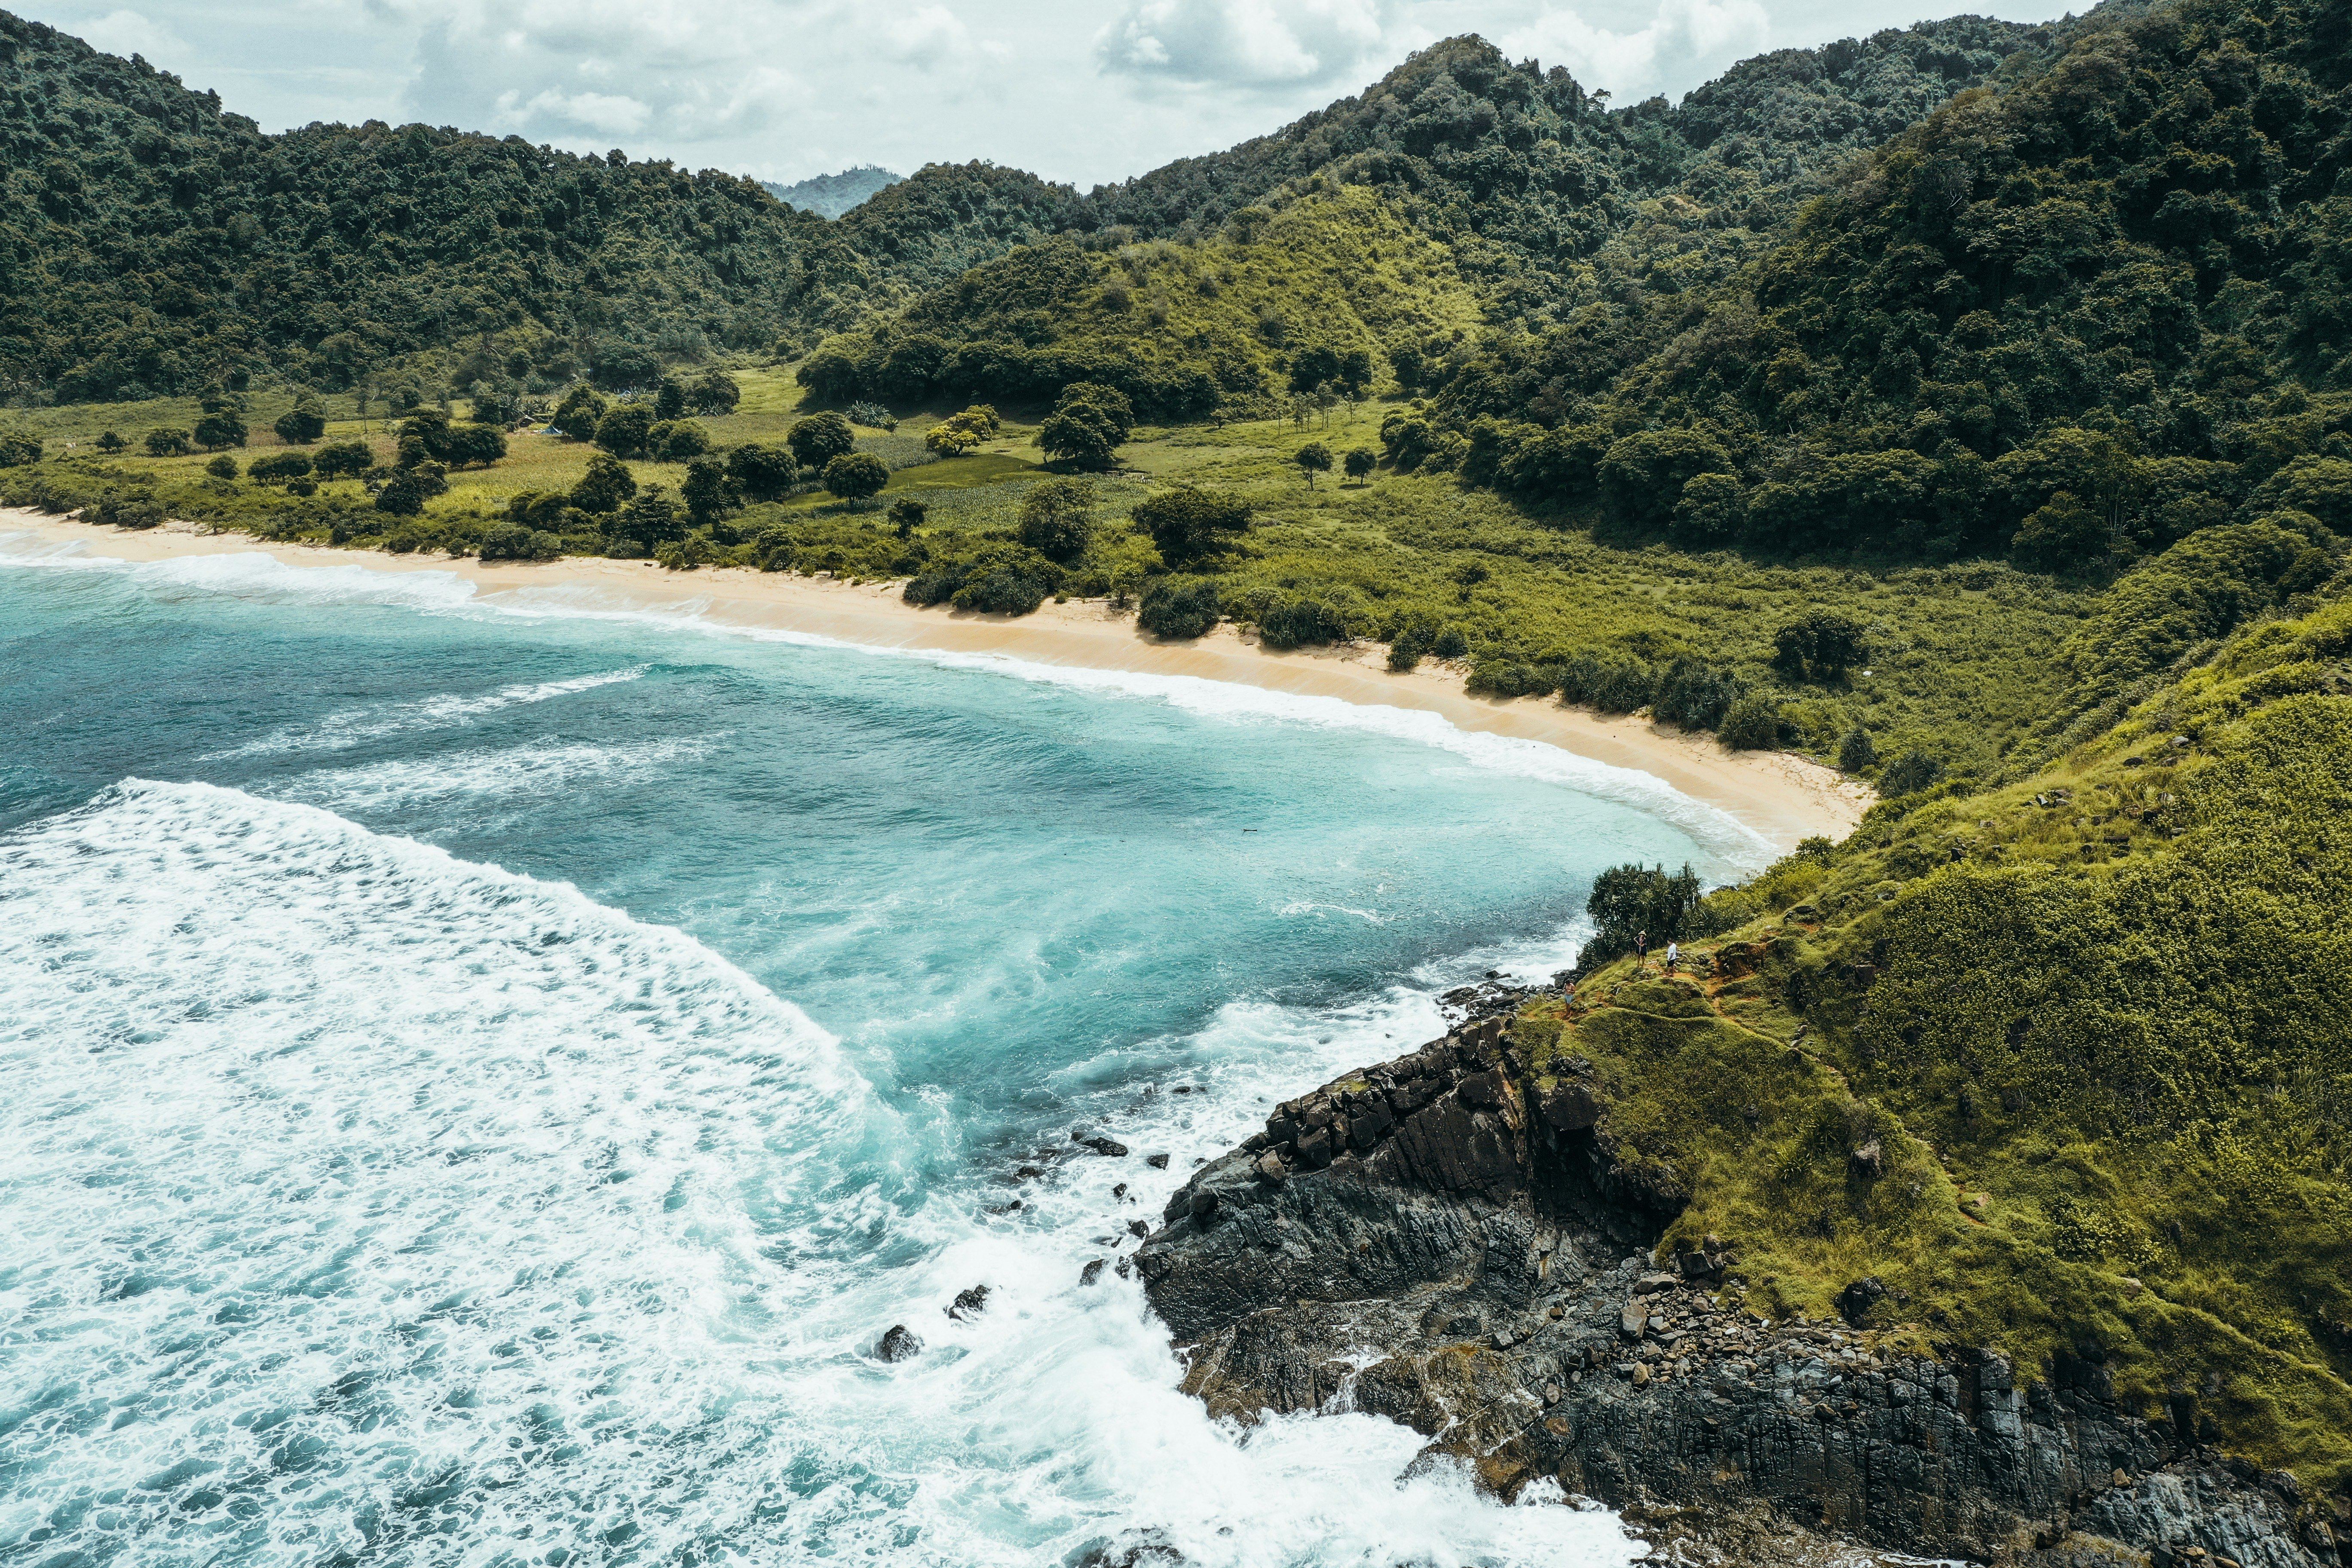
0, 508, 1874, 853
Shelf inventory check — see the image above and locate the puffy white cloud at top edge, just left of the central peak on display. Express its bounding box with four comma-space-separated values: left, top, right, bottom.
1093, 0, 1395, 87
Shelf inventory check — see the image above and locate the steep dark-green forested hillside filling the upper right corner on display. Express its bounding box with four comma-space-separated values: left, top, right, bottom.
1437, 0, 2352, 580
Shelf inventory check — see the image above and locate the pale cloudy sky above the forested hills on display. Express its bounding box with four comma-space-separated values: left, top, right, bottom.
14, 0, 2063, 188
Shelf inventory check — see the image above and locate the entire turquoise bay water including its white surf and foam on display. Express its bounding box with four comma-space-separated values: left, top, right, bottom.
0, 536, 1757, 1566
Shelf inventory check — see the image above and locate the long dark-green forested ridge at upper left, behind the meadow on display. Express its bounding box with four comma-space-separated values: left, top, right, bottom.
0, 12, 1075, 402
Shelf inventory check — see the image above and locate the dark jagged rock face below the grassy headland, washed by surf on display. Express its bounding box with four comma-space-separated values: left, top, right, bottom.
1134, 1016, 2352, 1568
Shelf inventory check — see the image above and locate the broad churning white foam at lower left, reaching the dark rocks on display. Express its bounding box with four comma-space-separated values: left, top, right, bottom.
0, 781, 1628, 1568
